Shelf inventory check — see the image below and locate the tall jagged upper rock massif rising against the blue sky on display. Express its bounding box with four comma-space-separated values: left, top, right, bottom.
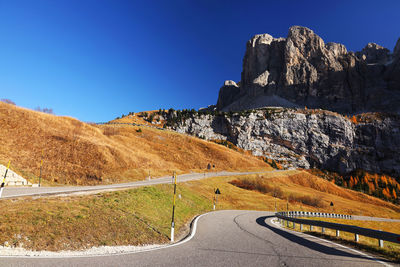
217, 26, 400, 113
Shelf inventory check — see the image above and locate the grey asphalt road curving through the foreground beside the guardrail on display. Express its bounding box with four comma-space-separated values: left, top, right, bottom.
0, 211, 392, 267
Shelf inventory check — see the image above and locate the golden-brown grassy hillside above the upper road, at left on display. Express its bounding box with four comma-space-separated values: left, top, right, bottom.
0, 102, 270, 185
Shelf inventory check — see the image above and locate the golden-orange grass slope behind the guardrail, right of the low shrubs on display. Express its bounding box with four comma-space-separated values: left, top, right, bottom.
225, 170, 400, 218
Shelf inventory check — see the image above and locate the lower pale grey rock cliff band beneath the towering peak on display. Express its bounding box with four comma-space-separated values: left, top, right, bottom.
173, 108, 400, 177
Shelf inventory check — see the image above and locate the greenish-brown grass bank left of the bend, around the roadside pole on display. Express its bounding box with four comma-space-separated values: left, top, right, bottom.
0, 185, 210, 251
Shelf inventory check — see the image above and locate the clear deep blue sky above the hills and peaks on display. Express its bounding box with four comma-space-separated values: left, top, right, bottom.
0, 0, 400, 122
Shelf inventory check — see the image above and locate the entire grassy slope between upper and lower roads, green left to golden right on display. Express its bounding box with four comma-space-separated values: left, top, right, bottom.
0, 171, 400, 250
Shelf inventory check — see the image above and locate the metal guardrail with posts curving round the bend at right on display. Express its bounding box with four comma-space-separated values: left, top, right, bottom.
275, 211, 400, 247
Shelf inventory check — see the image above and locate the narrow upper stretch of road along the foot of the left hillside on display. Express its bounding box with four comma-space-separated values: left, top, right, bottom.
1, 170, 266, 198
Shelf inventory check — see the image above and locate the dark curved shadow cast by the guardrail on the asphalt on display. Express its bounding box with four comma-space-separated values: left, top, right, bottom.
256, 216, 385, 261
